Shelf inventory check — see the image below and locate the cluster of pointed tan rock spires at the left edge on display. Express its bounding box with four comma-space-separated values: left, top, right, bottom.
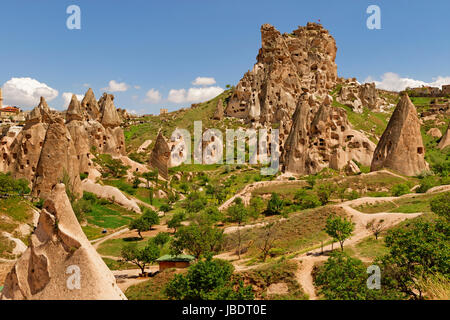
0, 89, 126, 198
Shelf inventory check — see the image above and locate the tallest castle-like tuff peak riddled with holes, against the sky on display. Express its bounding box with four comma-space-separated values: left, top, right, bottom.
225, 23, 337, 131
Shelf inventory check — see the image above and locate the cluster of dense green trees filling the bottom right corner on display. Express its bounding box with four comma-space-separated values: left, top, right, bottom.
315, 192, 450, 300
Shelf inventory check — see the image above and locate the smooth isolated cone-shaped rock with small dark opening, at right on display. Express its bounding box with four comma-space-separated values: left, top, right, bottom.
371, 93, 428, 176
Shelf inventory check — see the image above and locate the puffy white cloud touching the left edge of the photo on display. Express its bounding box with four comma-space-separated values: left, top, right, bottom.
2, 78, 58, 108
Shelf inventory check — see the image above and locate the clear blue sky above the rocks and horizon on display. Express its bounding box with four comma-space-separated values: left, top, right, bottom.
0, 0, 450, 113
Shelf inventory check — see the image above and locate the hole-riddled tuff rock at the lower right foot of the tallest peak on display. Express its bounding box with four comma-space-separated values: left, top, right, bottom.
281, 93, 375, 175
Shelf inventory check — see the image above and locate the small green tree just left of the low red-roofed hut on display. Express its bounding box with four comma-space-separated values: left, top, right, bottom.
120, 242, 160, 274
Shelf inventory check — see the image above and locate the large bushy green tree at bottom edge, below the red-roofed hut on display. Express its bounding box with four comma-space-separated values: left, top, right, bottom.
165, 256, 254, 300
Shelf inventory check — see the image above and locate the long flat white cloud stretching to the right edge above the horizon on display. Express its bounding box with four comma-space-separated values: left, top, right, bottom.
364, 72, 450, 91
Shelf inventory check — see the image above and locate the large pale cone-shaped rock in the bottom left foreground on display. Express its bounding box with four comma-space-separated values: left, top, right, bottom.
0, 184, 126, 300
